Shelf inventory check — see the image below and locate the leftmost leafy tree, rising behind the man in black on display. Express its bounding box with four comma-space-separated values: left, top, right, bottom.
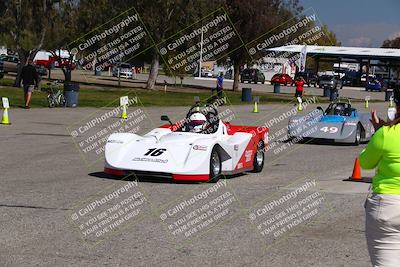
0, 0, 58, 87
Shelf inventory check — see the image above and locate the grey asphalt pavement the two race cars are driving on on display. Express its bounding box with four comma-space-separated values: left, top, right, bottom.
0, 101, 387, 266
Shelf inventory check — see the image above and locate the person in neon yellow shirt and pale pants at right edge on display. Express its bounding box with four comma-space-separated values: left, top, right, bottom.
359, 88, 400, 267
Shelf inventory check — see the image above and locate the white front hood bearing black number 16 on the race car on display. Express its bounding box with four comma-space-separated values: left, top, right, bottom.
105, 128, 215, 176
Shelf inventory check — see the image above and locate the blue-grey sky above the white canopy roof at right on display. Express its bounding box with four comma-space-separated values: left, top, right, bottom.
300, 0, 400, 47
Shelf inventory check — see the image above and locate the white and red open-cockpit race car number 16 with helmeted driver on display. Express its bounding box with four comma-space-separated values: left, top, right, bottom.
104, 104, 268, 182
